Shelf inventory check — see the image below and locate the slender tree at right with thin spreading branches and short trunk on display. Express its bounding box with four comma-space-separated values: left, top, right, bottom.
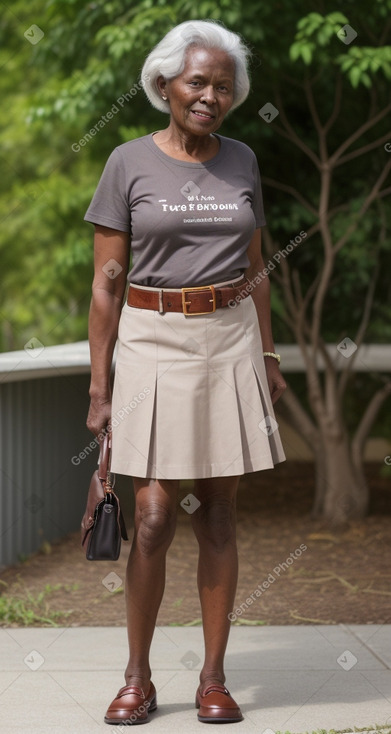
254, 3, 391, 523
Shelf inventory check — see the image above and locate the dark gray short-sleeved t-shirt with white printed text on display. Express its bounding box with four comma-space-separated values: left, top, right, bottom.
84, 133, 266, 288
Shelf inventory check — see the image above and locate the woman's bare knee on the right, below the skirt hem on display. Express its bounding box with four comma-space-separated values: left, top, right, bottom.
192, 498, 236, 551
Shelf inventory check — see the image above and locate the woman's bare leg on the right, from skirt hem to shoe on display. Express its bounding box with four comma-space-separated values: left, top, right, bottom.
191, 477, 240, 690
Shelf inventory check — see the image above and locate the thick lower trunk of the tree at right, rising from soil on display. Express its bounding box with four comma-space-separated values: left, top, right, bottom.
312, 434, 369, 526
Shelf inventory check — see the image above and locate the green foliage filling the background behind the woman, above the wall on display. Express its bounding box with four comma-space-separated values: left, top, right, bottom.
0, 0, 391, 442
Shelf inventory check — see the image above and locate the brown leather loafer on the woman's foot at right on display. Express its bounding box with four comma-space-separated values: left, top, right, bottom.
196, 683, 243, 724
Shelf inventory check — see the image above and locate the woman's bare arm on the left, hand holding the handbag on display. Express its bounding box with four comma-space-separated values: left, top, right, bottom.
87, 225, 130, 436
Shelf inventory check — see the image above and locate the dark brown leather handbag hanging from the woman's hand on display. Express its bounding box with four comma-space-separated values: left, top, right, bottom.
81, 432, 128, 561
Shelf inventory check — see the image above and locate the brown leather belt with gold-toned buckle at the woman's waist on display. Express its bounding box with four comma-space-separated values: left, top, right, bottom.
127, 277, 250, 316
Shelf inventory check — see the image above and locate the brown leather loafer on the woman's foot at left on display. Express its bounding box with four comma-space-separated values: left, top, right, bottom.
105, 681, 157, 724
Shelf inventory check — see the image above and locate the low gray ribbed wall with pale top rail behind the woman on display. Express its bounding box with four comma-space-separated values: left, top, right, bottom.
0, 342, 391, 568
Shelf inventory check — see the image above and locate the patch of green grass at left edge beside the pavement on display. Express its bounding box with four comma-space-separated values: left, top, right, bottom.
0, 581, 73, 627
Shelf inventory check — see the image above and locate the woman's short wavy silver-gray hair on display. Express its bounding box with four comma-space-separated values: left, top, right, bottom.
141, 20, 251, 113
